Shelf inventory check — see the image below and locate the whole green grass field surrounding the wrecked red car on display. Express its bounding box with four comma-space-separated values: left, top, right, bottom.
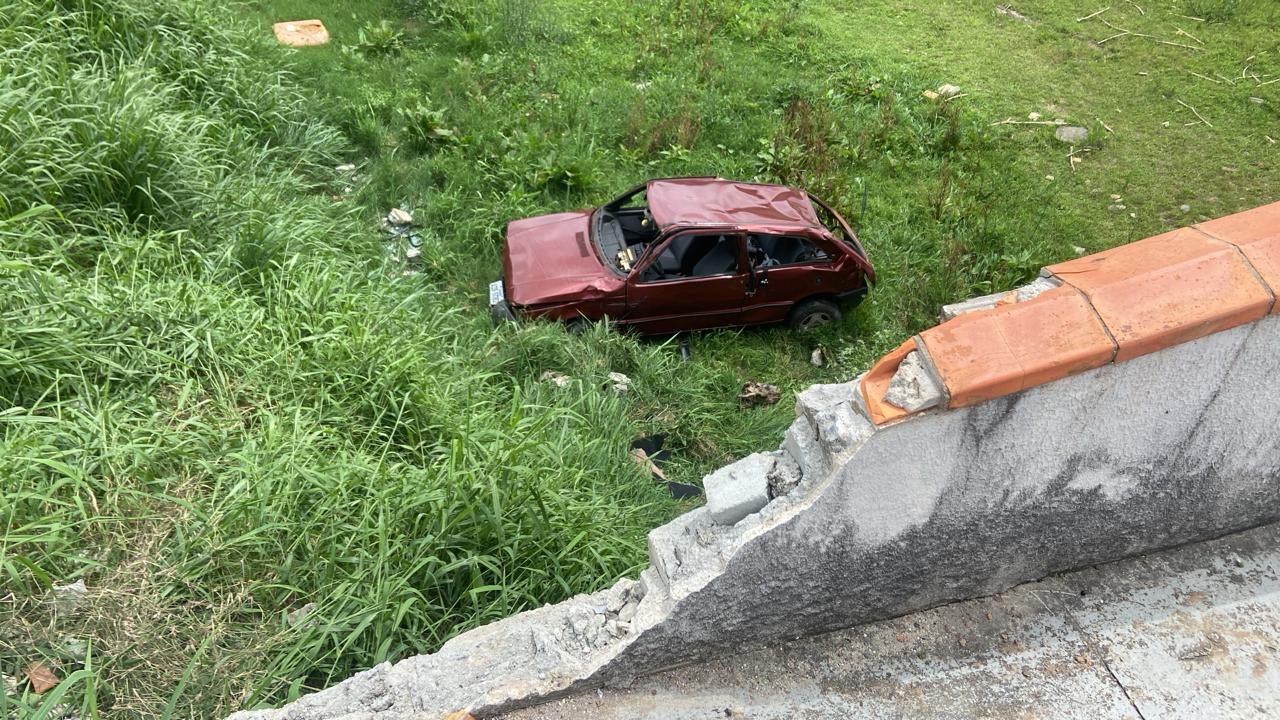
0, 0, 1280, 717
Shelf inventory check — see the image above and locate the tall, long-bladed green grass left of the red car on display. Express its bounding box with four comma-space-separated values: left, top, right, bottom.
0, 0, 672, 717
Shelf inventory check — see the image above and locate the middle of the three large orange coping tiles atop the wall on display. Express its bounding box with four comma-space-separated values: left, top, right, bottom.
1047, 228, 1272, 363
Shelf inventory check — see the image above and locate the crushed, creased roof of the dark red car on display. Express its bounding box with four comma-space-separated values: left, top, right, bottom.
646, 178, 822, 228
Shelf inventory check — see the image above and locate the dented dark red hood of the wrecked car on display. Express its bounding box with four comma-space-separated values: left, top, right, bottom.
502, 210, 623, 306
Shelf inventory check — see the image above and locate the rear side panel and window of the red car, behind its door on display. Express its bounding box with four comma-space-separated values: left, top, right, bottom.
741, 232, 844, 325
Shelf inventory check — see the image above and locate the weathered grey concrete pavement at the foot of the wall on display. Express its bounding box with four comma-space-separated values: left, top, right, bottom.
504, 525, 1280, 720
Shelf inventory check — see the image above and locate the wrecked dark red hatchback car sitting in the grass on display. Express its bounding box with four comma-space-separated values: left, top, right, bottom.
489, 178, 876, 334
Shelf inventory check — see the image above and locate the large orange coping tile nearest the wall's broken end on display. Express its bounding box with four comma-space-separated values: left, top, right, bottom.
920, 287, 1116, 407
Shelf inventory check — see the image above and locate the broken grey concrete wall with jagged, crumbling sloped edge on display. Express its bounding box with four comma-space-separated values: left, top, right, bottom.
238, 206, 1280, 720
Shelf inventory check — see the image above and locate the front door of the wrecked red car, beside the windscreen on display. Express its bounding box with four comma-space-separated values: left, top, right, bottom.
621, 229, 750, 334
